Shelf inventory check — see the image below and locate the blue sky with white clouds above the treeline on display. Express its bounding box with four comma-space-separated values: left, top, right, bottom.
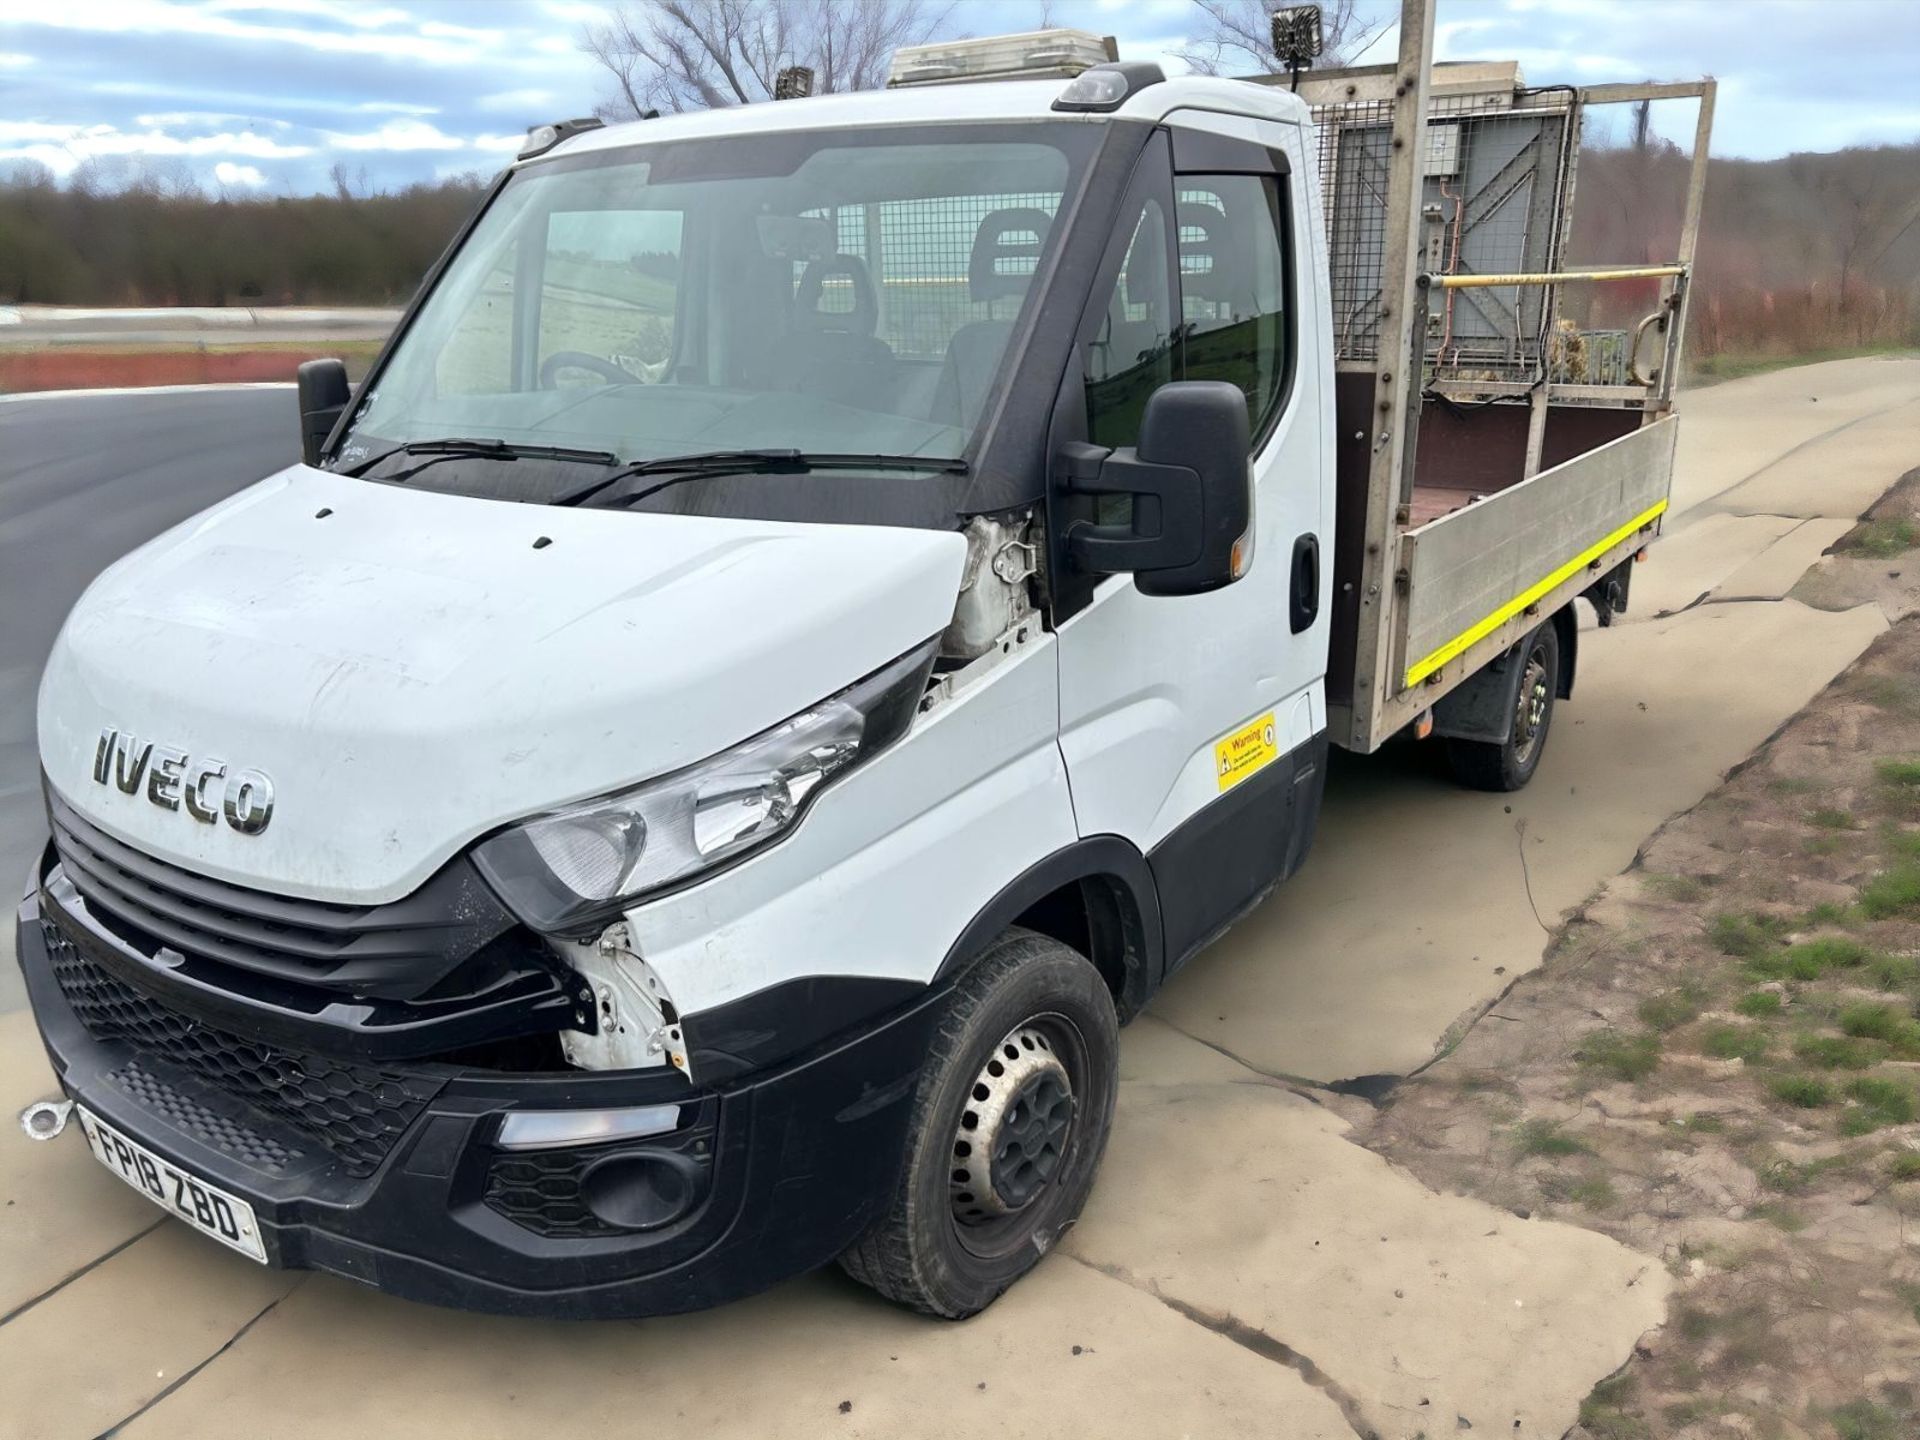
0, 0, 1920, 192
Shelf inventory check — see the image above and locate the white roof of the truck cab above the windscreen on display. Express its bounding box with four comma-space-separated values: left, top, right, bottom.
526, 75, 1308, 165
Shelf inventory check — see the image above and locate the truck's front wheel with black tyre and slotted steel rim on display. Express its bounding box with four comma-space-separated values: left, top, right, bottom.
841, 929, 1119, 1319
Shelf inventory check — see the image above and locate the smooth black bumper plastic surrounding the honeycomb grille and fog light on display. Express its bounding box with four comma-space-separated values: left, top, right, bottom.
17, 897, 945, 1319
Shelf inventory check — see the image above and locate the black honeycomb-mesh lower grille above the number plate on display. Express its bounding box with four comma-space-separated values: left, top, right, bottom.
40, 922, 442, 1177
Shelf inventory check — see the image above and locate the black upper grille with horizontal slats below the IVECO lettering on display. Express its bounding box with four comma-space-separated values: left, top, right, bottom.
46, 789, 515, 1000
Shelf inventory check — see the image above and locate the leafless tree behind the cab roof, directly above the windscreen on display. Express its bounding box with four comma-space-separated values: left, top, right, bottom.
580, 0, 952, 119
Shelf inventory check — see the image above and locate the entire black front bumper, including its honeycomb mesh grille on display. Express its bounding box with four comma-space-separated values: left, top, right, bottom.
17, 872, 939, 1319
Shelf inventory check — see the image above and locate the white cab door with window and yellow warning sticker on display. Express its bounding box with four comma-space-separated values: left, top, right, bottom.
1054, 111, 1332, 968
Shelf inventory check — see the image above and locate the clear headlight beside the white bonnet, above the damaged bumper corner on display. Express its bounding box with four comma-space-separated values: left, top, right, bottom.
474, 639, 939, 935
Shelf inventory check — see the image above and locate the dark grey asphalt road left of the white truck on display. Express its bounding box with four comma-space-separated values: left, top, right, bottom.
0, 386, 300, 1012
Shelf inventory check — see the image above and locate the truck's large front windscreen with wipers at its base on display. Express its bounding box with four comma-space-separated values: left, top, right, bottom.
338, 121, 1092, 497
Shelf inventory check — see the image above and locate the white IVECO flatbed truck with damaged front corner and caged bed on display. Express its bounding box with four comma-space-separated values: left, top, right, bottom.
19, 0, 1711, 1317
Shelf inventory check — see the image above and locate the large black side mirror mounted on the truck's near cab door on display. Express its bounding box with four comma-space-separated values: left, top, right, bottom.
1060, 380, 1254, 595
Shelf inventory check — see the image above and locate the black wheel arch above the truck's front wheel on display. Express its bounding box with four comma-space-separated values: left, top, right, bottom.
933, 835, 1164, 1023
